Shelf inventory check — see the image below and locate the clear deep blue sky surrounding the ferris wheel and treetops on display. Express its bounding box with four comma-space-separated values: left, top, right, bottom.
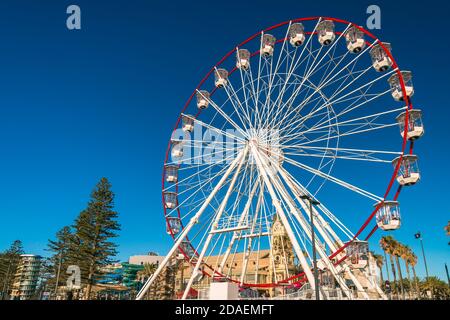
0, 0, 450, 278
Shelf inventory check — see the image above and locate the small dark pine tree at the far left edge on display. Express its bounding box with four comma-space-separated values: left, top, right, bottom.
0, 240, 24, 300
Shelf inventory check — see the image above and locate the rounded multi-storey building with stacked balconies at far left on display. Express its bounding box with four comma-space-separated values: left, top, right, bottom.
11, 254, 41, 300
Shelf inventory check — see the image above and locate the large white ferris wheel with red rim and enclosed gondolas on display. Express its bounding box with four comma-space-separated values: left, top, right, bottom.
137, 17, 424, 299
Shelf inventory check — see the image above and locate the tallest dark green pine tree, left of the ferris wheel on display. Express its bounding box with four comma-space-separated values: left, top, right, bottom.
70, 178, 120, 299
